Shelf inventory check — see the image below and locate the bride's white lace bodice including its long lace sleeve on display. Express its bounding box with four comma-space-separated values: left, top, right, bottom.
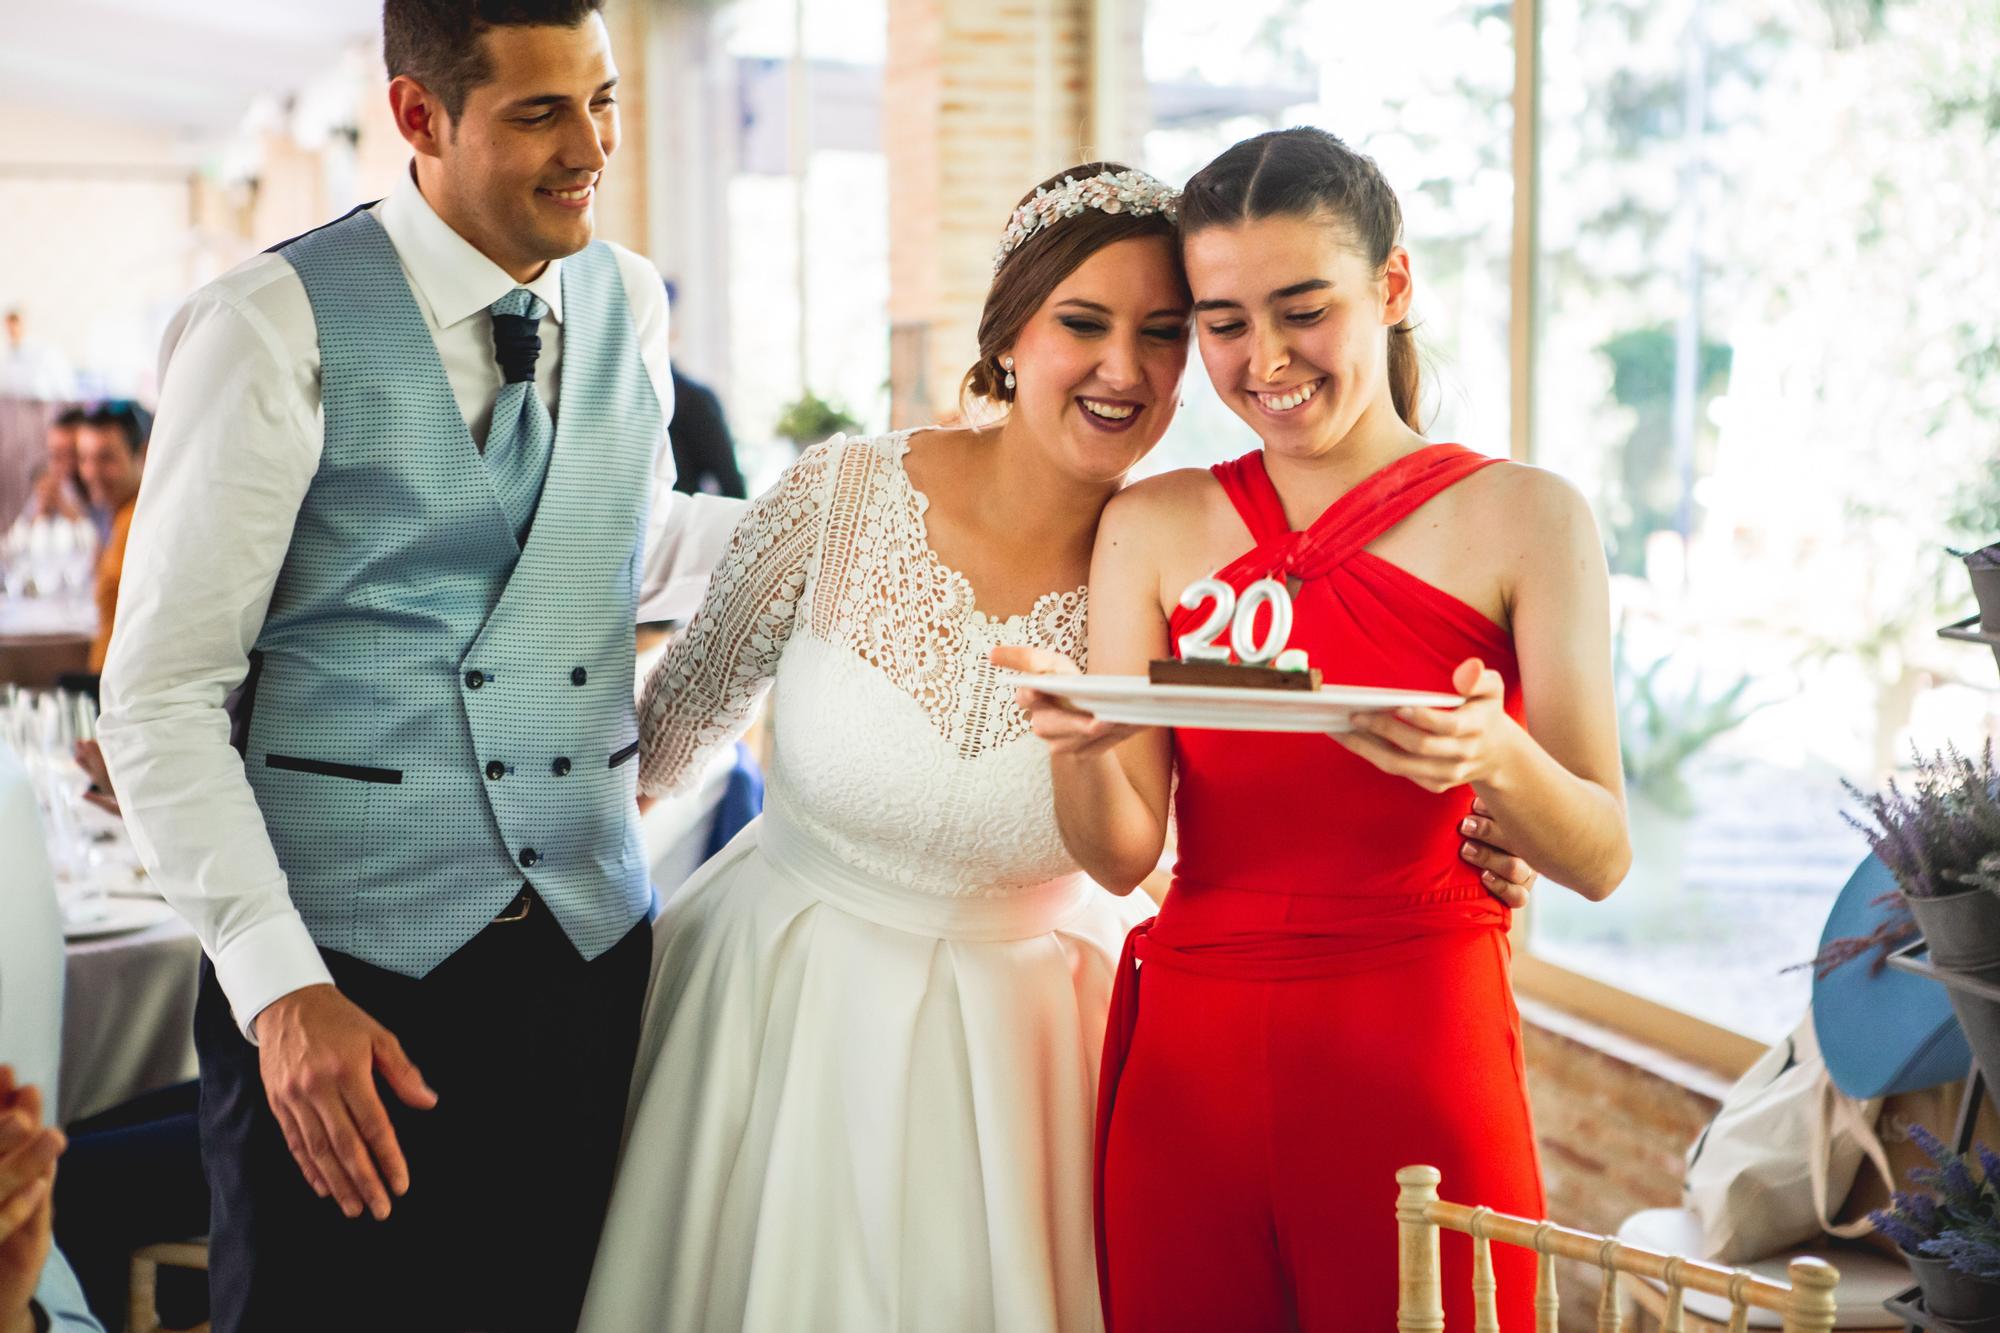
640, 432, 1086, 895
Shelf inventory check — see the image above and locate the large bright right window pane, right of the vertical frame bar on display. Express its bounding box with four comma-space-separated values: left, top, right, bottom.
1532, 0, 2000, 1041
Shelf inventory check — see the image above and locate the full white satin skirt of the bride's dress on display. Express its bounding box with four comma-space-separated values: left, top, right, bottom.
572, 811, 1152, 1333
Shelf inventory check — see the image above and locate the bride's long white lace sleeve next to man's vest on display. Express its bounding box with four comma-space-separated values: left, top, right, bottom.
638, 438, 838, 797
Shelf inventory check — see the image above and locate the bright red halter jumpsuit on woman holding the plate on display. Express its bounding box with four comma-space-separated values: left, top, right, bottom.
1098, 444, 1542, 1333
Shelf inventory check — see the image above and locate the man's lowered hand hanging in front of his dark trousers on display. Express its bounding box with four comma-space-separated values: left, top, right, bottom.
256, 985, 438, 1221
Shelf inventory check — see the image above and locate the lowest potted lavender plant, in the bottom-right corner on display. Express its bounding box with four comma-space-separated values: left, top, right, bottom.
1868, 1125, 2000, 1333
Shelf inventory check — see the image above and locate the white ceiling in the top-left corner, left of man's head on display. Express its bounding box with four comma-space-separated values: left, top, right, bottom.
0, 0, 382, 145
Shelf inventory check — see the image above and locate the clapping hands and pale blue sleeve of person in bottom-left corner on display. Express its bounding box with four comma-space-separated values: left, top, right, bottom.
0, 1065, 104, 1333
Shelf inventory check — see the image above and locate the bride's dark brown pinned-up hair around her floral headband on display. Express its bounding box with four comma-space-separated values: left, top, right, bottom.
958, 162, 1180, 404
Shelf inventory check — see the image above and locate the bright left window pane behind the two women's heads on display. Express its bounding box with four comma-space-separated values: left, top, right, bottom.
1142, 0, 1514, 472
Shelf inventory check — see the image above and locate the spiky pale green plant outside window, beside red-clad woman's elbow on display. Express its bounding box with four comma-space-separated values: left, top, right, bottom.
1612, 622, 1772, 815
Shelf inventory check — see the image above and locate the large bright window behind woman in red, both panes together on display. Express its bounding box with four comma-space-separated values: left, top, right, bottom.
1144, 0, 2000, 1065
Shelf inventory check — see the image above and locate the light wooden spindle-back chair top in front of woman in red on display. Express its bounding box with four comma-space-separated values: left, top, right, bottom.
1396, 1167, 1840, 1333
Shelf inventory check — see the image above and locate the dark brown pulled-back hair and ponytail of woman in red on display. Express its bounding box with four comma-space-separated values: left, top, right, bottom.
1180, 126, 1422, 430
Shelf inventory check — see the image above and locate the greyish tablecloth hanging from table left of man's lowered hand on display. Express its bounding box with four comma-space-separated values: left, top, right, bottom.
56, 904, 202, 1125
